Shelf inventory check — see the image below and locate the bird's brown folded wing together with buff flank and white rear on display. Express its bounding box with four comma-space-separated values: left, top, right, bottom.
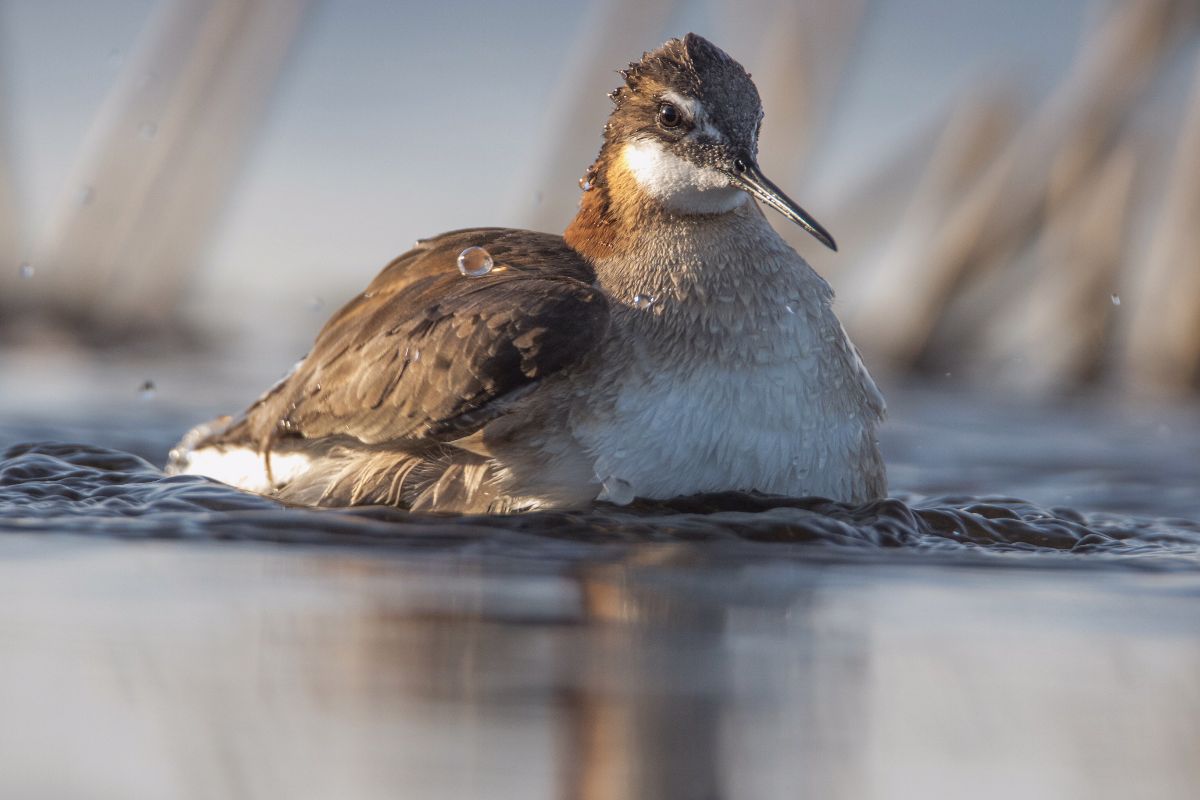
168, 228, 608, 510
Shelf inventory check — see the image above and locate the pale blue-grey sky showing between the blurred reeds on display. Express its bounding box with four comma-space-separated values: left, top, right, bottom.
0, 0, 1103, 323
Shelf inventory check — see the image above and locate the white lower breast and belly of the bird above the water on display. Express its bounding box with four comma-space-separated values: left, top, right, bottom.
574, 343, 880, 500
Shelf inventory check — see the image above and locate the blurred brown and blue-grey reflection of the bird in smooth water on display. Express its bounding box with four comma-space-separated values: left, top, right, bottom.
333, 545, 863, 800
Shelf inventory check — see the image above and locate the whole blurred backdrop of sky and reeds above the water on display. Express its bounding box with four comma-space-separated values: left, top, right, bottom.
0, 0, 1200, 403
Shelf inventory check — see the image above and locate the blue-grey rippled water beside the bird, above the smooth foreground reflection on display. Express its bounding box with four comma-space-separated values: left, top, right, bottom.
0, 381, 1200, 570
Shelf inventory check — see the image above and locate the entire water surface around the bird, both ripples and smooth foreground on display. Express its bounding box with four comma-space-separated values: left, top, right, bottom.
0, 381, 1200, 798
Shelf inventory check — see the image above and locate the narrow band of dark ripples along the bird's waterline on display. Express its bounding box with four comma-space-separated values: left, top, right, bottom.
7, 443, 1200, 570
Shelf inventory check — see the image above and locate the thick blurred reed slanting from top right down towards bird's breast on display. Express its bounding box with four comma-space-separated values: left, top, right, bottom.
850, 0, 1195, 365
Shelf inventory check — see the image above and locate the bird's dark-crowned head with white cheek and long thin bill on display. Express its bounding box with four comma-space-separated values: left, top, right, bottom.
589, 34, 838, 249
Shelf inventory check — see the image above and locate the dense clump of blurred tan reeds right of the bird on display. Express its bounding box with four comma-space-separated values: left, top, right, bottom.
841, 0, 1200, 393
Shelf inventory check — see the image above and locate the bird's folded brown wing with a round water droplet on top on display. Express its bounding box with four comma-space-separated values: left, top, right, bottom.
207, 228, 608, 449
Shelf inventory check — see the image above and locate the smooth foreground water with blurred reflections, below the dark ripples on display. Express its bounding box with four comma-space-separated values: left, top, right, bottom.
0, 535, 1200, 800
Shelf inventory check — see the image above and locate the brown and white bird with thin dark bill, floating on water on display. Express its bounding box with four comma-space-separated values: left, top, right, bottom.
167, 34, 887, 513
